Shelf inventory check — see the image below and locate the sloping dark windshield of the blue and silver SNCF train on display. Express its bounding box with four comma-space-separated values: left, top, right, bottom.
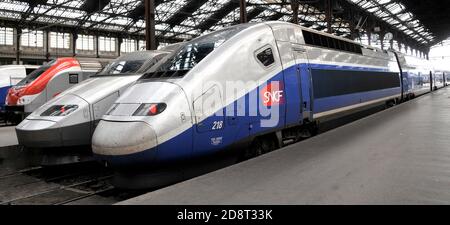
141, 24, 251, 79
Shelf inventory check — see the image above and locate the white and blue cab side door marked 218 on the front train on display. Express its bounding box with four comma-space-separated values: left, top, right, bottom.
193, 85, 232, 155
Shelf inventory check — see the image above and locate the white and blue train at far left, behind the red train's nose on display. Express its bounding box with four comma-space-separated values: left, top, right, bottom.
0, 65, 39, 117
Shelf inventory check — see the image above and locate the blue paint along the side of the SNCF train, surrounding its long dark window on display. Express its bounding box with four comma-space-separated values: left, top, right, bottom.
96, 64, 401, 166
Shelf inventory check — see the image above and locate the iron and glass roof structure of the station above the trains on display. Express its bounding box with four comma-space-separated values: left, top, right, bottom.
0, 0, 450, 48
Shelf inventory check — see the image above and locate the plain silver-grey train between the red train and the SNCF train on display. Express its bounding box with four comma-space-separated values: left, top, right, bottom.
16, 51, 168, 148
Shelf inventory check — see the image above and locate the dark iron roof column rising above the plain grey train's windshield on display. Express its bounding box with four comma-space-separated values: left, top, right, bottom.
144, 0, 157, 50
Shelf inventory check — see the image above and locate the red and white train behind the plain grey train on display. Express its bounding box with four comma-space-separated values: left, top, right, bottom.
5, 58, 109, 121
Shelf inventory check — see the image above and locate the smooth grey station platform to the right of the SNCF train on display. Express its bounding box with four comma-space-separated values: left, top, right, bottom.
119, 88, 450, 205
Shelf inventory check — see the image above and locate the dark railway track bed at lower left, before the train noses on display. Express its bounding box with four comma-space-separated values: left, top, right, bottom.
0, 163, 144, 205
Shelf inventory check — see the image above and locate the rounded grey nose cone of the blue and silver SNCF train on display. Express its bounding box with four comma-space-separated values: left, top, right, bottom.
92, 121, 157, 156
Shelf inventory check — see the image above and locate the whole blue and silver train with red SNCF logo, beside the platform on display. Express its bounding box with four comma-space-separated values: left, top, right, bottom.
86, 22, 444, 170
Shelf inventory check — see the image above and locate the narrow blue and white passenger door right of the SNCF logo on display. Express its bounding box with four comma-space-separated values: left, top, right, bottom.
292, 44, 313, 121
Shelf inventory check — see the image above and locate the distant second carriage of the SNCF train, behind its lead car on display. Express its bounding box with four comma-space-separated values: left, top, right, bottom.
395, 52, 435, 99
